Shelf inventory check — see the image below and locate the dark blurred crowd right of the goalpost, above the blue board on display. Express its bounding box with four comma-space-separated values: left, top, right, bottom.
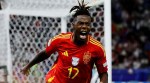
112, 0, 150, 69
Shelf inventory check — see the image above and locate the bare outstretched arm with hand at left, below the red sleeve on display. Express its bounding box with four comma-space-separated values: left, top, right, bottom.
21, 50, 49, 74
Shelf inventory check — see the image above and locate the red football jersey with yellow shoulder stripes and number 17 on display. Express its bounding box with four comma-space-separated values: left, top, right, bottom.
46, 33, 107, 83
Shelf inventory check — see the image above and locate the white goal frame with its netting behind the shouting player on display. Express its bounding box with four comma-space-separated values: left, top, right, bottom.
0, 0, 111, 83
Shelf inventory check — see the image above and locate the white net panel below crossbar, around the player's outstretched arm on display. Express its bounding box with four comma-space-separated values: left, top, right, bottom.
9, 15, 61, 83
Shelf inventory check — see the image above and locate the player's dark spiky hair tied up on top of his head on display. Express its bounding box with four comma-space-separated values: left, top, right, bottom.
70, 0, 91, 17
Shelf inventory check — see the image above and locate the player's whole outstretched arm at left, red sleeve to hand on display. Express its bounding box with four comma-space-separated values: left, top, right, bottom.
21, 35, 60, 74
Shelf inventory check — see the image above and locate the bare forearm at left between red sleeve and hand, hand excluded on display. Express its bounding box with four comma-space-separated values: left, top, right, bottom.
27, 50, 49, 69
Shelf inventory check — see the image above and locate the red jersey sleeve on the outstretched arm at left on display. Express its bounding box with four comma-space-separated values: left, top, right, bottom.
45, 36, 59, 56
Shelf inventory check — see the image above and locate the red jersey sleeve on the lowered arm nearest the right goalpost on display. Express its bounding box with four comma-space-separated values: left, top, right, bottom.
95, 46, 108, 74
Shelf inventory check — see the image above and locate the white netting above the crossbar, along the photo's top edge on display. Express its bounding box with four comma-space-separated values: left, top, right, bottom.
6, 0, 96, 10
